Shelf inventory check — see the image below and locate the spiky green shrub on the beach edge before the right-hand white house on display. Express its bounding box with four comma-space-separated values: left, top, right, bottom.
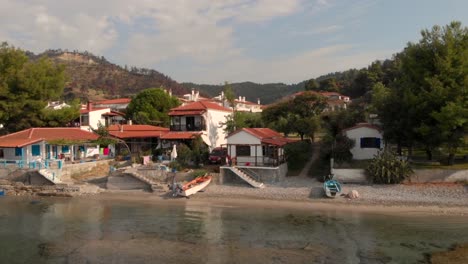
366, 150, 413, 184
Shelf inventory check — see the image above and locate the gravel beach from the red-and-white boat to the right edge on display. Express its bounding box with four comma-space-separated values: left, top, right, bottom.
197, 177, 468, 207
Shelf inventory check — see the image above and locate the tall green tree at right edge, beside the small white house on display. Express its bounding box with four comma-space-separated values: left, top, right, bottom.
400, 22, 468, 163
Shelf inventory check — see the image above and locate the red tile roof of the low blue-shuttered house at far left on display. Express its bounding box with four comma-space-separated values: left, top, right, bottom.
0, 127, 98, 148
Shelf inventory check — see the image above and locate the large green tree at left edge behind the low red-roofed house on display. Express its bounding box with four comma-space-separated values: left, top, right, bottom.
0, 43, 66, 132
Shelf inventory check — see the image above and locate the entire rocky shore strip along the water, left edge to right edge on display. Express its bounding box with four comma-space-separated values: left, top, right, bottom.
0, 177, 468, 215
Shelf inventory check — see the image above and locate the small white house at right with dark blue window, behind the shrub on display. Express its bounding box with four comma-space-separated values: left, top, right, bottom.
342, 123, 384, 160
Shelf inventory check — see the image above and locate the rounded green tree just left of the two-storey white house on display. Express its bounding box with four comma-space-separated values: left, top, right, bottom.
126, 88, 180, 126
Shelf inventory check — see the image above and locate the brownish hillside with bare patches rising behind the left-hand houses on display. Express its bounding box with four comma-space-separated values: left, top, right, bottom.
28, 50, 187, 100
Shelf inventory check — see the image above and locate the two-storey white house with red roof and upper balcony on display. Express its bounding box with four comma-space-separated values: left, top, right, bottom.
161, 101, 232, 149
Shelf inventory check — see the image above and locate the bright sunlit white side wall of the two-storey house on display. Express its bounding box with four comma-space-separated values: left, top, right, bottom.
202, 109, 232, 150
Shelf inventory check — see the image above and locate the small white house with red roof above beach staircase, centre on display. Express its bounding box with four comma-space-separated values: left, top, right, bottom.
227, 128, 293, 166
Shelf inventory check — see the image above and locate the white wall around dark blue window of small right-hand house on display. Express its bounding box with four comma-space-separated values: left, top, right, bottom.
346, 127, 383, 160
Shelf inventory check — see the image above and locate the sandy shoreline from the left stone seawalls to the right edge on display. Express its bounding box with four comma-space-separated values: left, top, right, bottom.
88, 177, 468, 215
